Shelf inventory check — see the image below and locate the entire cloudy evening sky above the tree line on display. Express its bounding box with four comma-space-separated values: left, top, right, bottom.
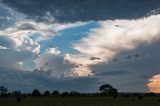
0, 0, 160, 93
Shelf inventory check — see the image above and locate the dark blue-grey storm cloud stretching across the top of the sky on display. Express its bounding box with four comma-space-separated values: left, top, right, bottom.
3, 0, 160, 22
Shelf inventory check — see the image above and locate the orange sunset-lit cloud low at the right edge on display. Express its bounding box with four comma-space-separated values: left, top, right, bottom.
147, 74, 160, 93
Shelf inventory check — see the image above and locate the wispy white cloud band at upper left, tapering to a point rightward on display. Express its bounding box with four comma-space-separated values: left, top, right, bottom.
0, 19, 87, 41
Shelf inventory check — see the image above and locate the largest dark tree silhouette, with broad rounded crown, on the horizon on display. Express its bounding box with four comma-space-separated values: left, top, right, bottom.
99, 84, 118, 96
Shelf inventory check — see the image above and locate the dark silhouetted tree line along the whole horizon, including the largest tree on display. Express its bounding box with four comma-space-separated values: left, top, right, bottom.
0, 84, 160, 99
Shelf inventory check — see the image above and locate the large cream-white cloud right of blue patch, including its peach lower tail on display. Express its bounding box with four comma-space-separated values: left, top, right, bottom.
61, 15, 160, 79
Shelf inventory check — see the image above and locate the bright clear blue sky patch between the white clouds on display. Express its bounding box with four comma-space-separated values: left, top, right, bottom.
50, 21, 99, 53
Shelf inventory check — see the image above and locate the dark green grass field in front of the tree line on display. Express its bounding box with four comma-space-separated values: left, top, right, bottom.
0, 96, 160, 106
